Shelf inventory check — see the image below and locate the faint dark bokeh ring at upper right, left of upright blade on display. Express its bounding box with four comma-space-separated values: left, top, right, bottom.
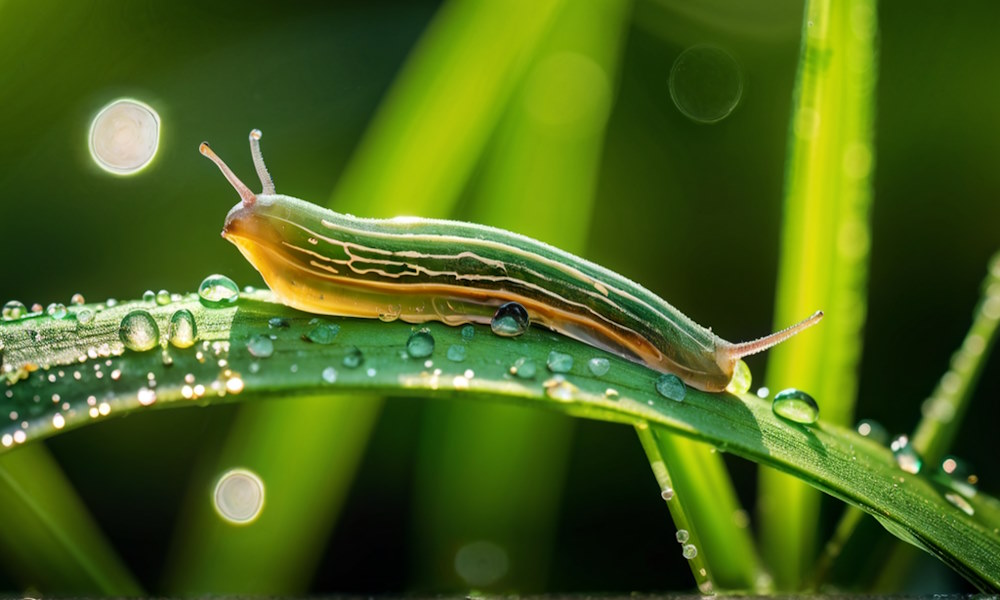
669, 45, 743, 123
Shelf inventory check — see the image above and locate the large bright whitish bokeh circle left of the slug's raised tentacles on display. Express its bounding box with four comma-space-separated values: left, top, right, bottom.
89, 98, 160, 175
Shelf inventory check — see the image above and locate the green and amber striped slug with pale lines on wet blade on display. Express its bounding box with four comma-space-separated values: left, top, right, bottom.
200, 130, 823, 392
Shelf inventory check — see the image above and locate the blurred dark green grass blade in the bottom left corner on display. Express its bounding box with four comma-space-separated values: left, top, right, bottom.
0, 445, 144, 596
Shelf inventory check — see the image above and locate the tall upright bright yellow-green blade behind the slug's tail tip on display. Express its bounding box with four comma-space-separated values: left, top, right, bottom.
759, 0, 877, 590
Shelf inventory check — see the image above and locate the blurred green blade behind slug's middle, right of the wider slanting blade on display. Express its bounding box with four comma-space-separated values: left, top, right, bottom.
413, 0, 631, 591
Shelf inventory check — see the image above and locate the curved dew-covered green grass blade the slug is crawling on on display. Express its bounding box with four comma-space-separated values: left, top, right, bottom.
0, 292, 1000, 590
